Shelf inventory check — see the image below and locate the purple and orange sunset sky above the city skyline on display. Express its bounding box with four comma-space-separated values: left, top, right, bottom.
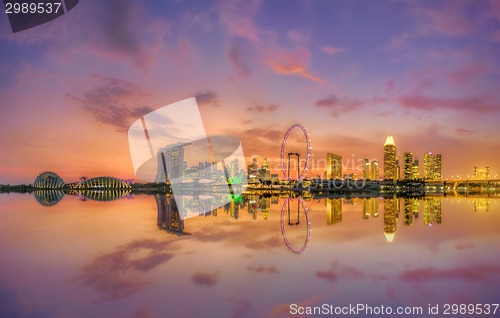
0, 0, 500, 184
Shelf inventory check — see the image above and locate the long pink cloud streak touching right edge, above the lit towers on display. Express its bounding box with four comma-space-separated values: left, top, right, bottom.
399, 95, 500, 113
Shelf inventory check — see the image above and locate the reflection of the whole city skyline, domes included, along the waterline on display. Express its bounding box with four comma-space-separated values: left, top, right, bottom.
34, 189, 472, 250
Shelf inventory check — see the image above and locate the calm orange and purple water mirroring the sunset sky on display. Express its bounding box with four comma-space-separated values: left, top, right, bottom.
0, 194, 500, 317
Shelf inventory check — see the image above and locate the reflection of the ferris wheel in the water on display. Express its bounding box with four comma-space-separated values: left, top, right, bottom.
281, 197, 311, 254
